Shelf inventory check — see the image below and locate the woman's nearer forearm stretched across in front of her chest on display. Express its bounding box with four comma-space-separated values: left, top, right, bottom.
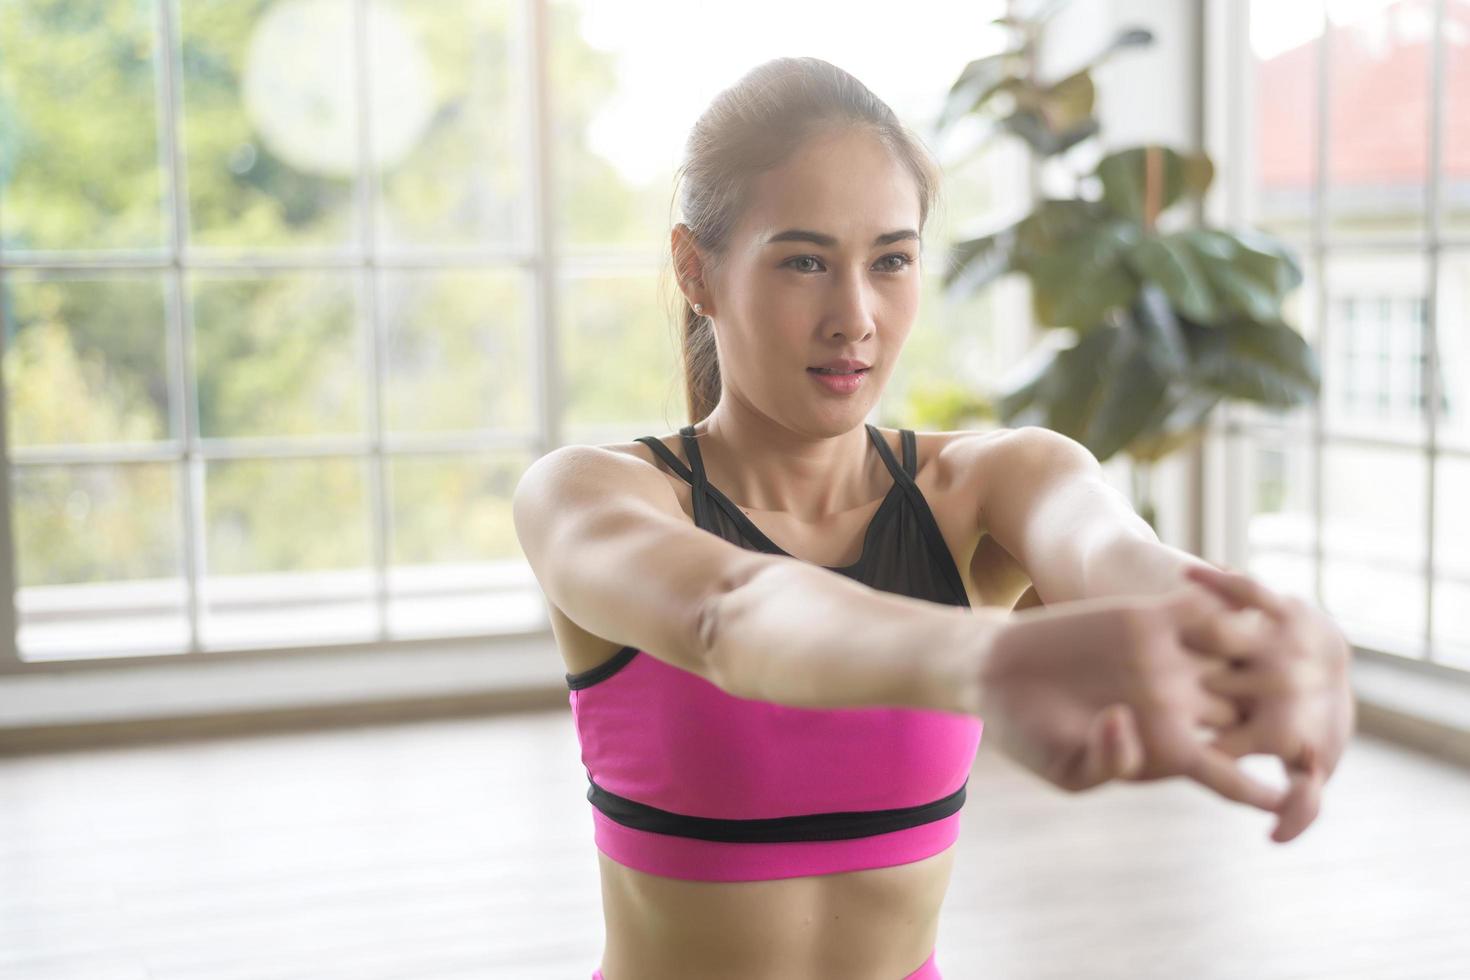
706, 560, 1007, 714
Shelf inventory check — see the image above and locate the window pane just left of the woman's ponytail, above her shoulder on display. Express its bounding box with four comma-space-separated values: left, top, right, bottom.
557, 268, 686, 442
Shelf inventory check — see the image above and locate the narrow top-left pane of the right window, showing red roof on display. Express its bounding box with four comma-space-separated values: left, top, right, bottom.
1251, 0, 1323, 238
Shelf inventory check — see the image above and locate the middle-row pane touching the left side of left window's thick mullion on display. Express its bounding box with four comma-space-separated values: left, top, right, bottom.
378, 270, 532, 432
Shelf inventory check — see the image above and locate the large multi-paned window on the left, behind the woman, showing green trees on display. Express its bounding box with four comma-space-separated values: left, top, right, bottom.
0, 0, 1025, 670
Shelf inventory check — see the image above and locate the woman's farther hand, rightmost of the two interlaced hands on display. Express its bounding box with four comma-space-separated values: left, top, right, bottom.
1185, 566, 1357, 843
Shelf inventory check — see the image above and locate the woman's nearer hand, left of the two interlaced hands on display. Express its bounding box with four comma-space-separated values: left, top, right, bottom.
979, 583, 1282, 811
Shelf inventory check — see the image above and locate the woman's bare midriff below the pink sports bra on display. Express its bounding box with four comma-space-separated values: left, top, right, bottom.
597, 846, 954, 980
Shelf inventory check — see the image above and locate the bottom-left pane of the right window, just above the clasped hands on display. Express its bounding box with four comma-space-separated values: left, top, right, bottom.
1244, 432, 1316, 555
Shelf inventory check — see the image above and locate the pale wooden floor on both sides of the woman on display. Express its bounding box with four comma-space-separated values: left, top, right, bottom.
0, 711, 1470, 980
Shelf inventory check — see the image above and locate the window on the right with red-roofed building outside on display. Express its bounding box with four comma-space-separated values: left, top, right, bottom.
1210, 0, 1470, 669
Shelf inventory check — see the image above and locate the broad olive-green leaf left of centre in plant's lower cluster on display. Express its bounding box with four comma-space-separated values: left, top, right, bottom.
1022, 220, 1141, 331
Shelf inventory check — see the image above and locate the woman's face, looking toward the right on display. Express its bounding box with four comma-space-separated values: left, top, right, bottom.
699, 129, 920, 435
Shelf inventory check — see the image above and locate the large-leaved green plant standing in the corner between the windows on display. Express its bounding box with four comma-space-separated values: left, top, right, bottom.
935, 0, 1320, 525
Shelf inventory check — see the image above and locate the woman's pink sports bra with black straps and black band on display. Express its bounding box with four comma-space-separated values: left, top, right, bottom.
566, 425, 982, 882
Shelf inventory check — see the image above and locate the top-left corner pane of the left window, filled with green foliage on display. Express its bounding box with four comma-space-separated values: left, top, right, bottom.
0, 0, 168, 251
